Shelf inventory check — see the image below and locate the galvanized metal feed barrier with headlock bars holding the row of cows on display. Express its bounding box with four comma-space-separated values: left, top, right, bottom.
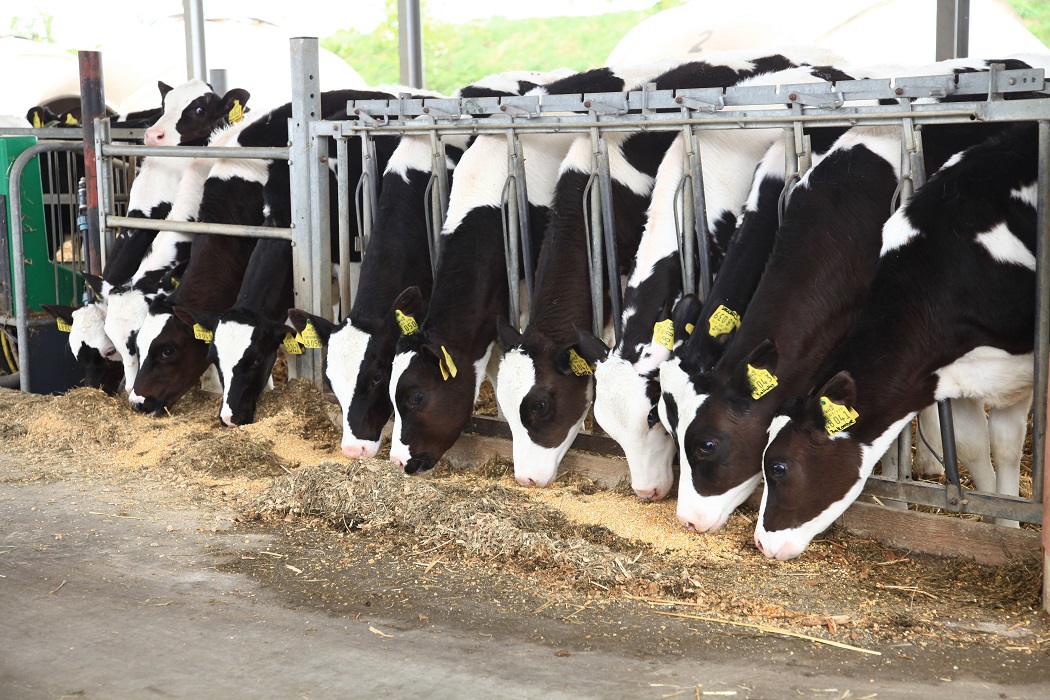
2, 39, 1050, 587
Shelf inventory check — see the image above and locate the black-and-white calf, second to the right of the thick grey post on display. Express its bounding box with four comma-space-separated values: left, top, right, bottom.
390, 69, 623, 473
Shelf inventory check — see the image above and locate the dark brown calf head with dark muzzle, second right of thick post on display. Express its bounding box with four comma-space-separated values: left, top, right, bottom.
390, 293, 480, 474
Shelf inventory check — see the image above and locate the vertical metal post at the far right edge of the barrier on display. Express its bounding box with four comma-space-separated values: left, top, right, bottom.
1032, 122, 1050, 612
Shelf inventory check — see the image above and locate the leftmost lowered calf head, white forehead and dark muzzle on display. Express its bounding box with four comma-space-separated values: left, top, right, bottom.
41, 301, 124, 394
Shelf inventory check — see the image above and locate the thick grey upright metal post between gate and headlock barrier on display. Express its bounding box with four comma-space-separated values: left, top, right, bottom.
288, 37, 323, 387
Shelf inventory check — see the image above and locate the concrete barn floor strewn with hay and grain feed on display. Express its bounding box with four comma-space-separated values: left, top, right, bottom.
0, 386, 1050, 698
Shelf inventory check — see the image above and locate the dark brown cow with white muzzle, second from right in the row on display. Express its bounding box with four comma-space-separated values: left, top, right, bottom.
677, 59, 1041, 532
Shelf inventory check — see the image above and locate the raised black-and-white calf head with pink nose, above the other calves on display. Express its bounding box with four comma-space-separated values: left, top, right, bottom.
143, 80, 248, 146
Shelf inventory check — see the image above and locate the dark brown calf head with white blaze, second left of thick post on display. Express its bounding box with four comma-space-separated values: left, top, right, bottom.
128, 299, 208, 416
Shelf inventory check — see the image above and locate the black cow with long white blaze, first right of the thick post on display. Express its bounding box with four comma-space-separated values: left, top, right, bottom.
289, 71, 564, 459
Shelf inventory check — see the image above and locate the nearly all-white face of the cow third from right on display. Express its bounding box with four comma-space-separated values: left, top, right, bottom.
594, 356, 674, 501
